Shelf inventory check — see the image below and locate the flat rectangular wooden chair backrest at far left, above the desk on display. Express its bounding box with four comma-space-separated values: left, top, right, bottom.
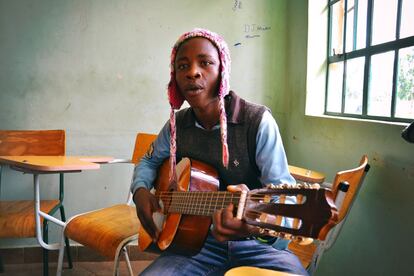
0, 130, 66, 156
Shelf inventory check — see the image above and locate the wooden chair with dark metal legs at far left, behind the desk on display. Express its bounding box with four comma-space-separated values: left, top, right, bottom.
0, 130, 72, 275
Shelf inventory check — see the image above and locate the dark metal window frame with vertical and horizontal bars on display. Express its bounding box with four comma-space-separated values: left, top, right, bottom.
323, 0, 414, 123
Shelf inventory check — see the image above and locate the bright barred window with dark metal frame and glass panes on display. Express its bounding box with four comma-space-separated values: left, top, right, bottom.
324, 0, 414, 122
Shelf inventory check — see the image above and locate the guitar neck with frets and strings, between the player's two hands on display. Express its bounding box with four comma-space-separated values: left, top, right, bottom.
157, 191, 240, 216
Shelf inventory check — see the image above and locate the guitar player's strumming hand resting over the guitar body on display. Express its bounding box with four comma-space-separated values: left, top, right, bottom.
133, 188, 161, 242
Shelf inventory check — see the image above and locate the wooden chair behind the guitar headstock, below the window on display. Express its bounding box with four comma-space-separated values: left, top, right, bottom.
289, 155, 370, 275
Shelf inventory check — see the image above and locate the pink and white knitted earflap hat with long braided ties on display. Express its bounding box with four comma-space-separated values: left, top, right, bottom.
168, 29, 231, 180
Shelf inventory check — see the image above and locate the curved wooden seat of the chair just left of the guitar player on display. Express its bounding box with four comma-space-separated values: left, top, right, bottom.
65, 204, 139, 259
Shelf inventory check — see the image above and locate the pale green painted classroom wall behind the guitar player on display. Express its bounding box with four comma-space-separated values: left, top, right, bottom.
0, 0, 414, 275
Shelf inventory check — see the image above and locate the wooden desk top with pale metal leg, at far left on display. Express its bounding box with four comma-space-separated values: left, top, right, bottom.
0, 156, 113, 250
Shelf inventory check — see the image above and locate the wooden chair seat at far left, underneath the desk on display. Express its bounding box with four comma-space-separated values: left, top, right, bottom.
0, 199, 59, 238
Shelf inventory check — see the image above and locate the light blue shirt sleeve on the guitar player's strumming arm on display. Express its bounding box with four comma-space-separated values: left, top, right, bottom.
131, 121, 170, 194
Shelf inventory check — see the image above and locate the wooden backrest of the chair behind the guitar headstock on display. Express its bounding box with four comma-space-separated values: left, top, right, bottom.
332, 155, 369, 221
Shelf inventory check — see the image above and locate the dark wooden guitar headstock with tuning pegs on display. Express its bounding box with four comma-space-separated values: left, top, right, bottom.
243, 184, 338, 241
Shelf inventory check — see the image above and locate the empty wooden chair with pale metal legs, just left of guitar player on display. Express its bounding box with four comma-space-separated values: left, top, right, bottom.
57, 133, 157, 275
